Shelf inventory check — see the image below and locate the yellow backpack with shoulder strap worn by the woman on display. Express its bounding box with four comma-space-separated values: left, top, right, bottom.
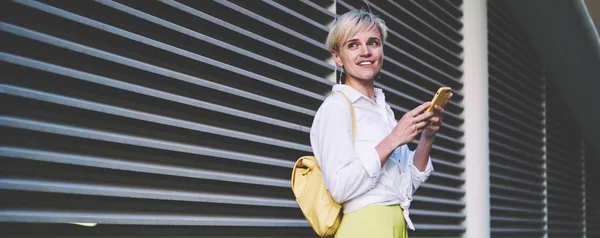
292, 92, 356, 237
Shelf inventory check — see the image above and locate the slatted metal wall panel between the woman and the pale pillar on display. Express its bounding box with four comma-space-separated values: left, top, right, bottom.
336, 0, 465, 237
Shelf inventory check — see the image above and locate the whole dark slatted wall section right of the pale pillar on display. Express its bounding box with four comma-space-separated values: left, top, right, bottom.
488, 0, 599, 237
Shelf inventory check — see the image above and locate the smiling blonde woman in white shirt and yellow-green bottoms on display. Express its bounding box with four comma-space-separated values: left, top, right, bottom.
310, 11, 444, 238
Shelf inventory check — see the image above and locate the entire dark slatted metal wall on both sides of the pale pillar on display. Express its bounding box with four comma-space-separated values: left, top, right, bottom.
0, 0, 599, 237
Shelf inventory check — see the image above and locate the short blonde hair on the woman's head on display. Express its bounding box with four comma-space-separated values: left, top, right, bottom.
325, 10, 387, 52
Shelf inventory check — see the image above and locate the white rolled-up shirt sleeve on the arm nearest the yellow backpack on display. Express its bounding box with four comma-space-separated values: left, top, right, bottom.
310, 96, 381, 203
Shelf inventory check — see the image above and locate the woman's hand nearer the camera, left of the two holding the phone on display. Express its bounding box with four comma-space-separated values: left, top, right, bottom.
390, 102, 434, 146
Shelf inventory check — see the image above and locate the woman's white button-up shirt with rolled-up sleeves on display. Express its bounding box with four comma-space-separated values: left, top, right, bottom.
310, 84, 433, 230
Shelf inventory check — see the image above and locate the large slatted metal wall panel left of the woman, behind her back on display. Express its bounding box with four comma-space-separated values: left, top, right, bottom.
0, 0, 334, 237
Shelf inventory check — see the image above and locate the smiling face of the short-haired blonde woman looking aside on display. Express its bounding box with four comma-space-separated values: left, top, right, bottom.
332, 27, 383, 81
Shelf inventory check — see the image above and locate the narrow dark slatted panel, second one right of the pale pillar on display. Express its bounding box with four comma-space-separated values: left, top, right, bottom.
546, 84, 593, 238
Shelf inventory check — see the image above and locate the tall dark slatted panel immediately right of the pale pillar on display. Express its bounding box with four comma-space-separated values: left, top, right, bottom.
488, 1, 546, 237
